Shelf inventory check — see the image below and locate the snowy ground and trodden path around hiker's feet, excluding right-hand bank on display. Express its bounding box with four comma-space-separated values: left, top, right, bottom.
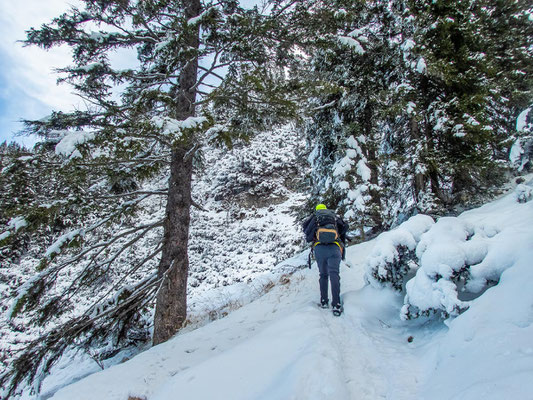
47, 242, 438, 400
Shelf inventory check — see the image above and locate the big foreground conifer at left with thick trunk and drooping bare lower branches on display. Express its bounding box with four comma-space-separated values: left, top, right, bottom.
1, 0, 295, 395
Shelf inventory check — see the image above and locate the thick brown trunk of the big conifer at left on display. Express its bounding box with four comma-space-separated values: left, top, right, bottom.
153, 0, 201, 345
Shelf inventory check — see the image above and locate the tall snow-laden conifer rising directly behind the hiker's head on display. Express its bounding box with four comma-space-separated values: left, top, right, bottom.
296, 1, 412, 232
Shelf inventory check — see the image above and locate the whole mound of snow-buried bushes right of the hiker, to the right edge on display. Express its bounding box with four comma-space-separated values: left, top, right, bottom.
365, 185, 533, 319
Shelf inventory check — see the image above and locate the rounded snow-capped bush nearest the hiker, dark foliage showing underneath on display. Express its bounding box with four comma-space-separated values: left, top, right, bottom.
366, 215, 487, 319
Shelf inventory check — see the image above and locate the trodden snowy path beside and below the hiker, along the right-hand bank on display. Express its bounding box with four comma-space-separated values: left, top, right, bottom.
304, 242, 435, 400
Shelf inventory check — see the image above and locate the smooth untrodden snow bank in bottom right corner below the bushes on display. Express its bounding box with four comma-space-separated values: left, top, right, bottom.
422, 248, 533, 400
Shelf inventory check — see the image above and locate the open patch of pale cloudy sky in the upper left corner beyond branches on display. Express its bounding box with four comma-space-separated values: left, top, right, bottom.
0, 0, 80, 146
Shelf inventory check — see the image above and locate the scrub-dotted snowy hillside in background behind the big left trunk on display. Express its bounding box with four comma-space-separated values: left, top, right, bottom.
0, 125, 307, 397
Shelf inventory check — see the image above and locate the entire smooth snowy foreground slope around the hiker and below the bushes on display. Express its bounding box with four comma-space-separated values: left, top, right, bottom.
43, 182, 533, 400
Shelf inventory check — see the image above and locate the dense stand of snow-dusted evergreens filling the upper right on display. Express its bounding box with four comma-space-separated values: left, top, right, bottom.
298, 0, 531, 229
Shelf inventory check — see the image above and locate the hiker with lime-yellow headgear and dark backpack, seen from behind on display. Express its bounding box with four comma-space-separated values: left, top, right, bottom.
302, 204, 348, 316
